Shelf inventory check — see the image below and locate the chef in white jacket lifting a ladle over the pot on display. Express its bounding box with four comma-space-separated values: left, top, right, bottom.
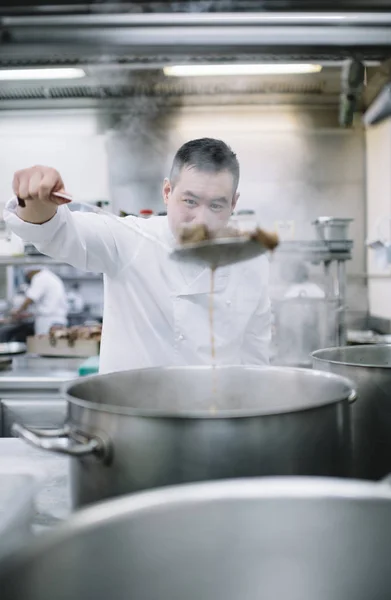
4, 138, 270, 373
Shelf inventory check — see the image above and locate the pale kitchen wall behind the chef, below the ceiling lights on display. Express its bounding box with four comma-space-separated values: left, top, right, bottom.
0, 101, 367, 322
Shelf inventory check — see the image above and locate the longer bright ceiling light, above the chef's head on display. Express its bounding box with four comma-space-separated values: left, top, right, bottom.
163, 63, 322, 77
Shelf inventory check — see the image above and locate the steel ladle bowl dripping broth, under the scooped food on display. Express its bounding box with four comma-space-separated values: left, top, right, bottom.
170, 237, 268, 269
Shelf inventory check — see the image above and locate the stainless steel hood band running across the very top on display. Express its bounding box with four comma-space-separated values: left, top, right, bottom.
0, 12, 391, 61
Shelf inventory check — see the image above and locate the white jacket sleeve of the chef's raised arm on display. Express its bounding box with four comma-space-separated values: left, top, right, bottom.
4, 199, 142, 276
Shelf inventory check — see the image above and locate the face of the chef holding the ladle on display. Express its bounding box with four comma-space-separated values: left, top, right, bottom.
163, 167, 239, 236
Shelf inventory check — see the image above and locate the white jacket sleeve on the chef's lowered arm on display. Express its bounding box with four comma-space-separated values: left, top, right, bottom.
241, 264, 272, 366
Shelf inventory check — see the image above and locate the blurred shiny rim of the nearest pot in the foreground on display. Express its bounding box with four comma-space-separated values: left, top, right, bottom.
0, 476, 391, 578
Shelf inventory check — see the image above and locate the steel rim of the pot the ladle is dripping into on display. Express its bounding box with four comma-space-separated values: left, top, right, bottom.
66, 365, 355, 420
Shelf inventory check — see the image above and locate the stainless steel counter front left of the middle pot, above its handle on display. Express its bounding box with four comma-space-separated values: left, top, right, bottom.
0, 395, 67, 437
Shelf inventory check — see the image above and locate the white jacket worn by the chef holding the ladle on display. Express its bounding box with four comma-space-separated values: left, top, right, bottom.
4, 200, 271, 373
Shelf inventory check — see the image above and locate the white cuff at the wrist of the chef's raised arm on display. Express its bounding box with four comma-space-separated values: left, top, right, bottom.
3, 198, 69, 244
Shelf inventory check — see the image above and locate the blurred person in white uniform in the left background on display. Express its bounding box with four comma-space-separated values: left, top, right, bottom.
13, 267, 68, 335
